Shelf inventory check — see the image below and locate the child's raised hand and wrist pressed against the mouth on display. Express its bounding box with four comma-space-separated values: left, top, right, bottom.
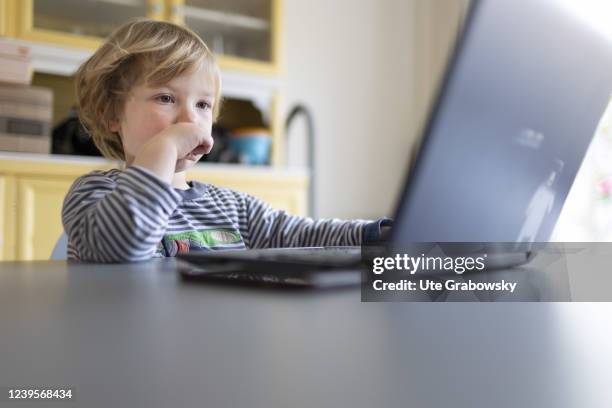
133, 122, 214, 183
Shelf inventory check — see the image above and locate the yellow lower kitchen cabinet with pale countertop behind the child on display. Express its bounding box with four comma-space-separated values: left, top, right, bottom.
0, 154, 308, 261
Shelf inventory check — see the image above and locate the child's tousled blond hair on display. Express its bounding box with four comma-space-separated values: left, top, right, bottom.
75, 19, 221, 160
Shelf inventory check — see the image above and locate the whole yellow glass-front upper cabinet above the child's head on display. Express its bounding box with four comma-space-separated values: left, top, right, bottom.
0, 0, 281, 74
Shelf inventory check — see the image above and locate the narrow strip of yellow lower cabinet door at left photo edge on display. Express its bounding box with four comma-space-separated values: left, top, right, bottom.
0, 175, 17, 261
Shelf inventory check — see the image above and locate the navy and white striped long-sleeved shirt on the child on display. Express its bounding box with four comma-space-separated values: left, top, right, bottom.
62, 166, 378, 262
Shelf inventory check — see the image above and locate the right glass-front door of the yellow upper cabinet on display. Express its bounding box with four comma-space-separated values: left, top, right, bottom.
169, 0, 281, 74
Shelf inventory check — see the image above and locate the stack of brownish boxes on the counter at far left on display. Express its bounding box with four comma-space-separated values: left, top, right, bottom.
0, 41, 53, 153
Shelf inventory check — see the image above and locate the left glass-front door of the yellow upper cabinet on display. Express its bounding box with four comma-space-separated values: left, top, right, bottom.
12, 0, 164, 49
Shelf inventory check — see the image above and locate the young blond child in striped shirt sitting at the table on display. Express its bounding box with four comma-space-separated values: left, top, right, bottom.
62, 20, 387, 262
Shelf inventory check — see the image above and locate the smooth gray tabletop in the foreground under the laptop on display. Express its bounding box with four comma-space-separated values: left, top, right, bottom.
0, 259, 612, 408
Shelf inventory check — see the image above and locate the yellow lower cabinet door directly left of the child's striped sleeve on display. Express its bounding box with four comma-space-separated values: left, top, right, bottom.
17, 177, 74, 261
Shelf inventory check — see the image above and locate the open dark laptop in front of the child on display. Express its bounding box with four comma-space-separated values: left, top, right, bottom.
179, 0, 612, 286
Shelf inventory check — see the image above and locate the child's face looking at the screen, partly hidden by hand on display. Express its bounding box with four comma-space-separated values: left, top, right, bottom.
111, 63, 215, 172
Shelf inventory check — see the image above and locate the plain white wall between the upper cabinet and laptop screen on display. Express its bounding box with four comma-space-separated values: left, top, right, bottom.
283, 0, 463, 218
